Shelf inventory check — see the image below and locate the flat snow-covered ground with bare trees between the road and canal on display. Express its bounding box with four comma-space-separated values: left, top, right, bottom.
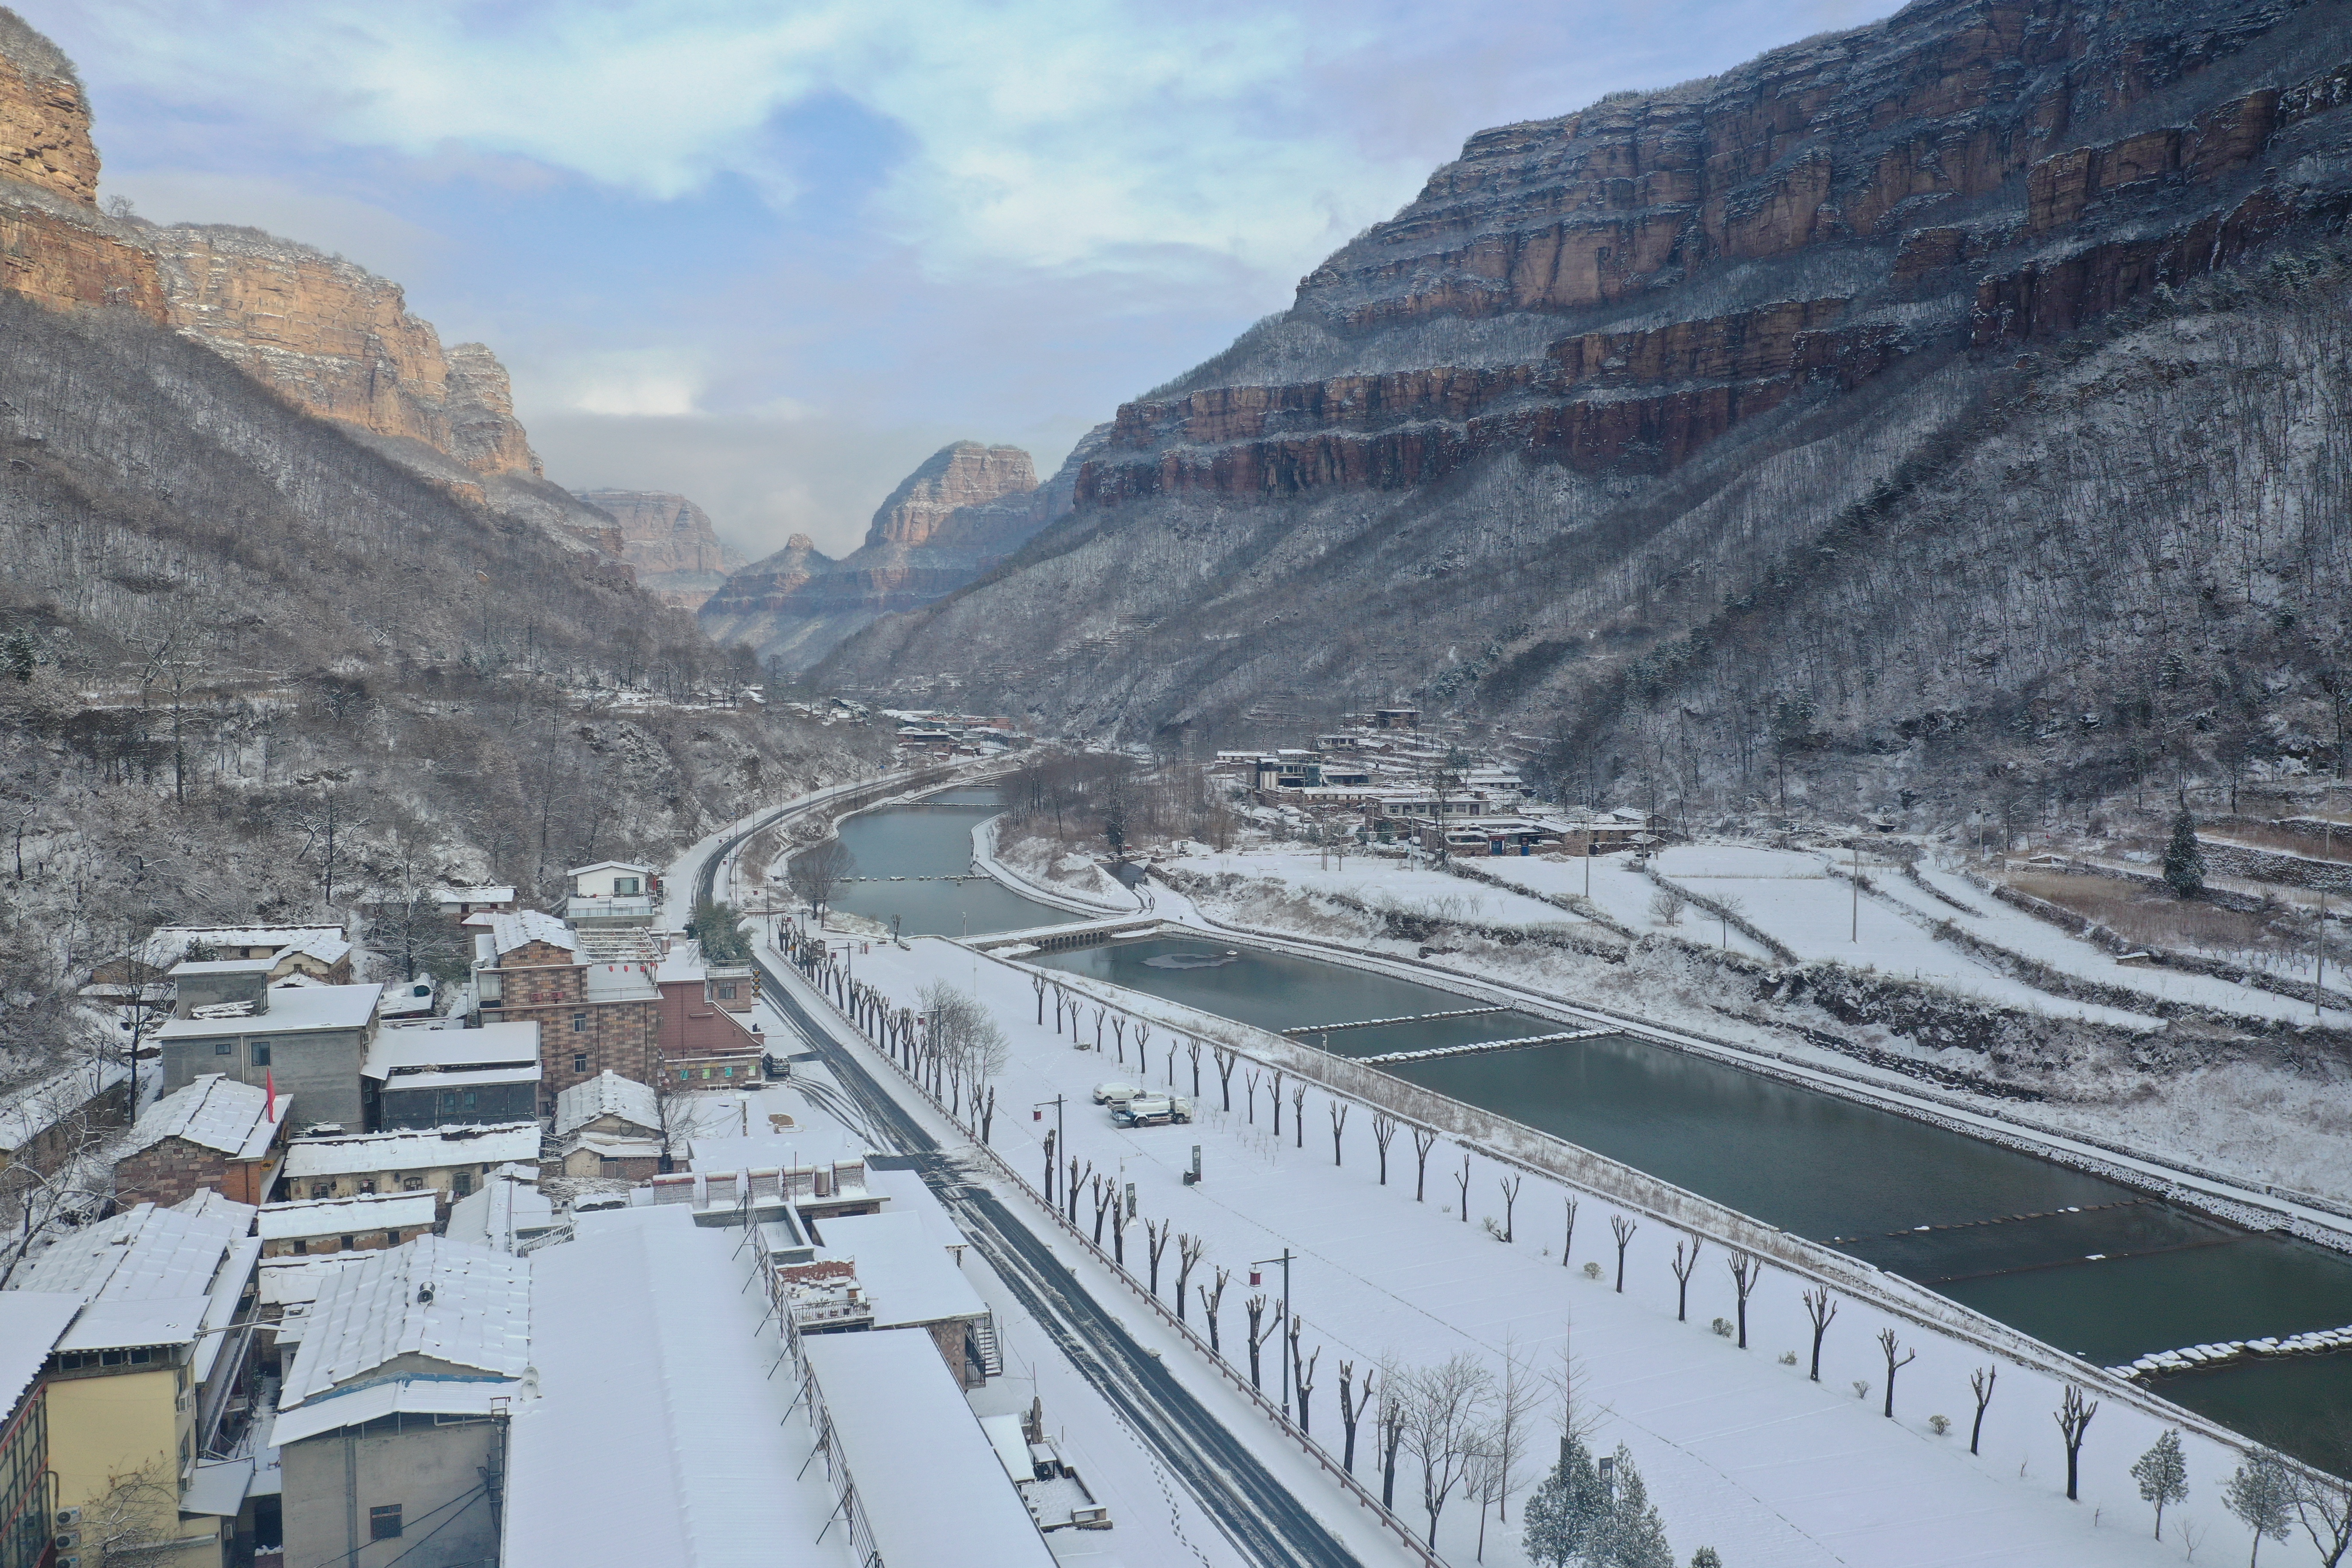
804, 938, 2276, 1568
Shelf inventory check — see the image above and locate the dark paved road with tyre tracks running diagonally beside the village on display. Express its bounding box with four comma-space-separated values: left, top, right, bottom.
701, 799, 1357, 1568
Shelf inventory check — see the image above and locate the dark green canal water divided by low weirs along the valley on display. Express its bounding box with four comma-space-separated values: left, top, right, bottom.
814, 790, 2352, 1469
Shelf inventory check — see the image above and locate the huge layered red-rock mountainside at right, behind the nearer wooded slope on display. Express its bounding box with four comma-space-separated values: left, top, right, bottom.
818, 0, 2352, 790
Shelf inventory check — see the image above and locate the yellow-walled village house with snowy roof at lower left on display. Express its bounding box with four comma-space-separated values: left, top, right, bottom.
9, 1192, 261, 1568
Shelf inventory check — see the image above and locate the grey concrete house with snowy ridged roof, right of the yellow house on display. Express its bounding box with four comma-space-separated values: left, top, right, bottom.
270, 1237, 532, 1568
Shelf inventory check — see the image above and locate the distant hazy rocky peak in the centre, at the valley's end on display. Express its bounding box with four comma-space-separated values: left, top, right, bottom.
701, 442, 1054, 670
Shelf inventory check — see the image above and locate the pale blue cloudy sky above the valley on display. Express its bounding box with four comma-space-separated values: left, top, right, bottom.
32, 0, 1893, 555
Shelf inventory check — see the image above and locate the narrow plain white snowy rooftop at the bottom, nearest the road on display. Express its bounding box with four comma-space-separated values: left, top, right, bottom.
802, 1328, 1054, 1568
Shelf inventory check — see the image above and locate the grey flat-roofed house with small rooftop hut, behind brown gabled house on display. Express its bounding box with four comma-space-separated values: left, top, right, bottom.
155, 959, 383, 1126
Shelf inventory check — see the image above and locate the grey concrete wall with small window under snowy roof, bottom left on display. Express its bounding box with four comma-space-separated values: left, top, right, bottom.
280, 1415, 505, 1568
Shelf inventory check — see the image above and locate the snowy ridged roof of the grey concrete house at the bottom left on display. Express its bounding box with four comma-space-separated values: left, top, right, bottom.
278, 1237, 532, 1410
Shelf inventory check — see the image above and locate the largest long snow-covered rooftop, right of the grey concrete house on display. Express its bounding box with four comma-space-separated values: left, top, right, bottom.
505, 1208, 846, 1568
